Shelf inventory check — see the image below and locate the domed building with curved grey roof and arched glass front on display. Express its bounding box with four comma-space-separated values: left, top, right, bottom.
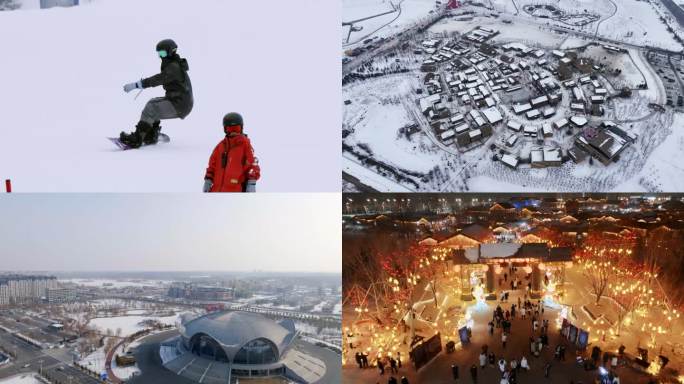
179, 311, 296, 376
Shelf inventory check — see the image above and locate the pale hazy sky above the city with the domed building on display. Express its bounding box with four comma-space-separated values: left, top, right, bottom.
0, 193, 342, 272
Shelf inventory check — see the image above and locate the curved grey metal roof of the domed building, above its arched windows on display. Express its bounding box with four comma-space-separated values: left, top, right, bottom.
181, 311, 295, 361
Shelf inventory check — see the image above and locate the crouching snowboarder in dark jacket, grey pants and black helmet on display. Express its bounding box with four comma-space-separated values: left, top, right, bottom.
119, 39, 193, 148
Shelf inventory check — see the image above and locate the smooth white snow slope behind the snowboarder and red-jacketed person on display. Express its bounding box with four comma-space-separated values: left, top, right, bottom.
0, 0, 341, 192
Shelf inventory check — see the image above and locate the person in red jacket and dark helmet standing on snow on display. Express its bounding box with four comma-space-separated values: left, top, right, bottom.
203, 112, 261, 192
